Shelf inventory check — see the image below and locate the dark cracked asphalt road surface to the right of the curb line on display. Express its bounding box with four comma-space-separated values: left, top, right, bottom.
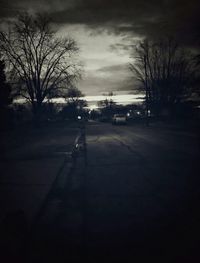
28, 123, 200, 262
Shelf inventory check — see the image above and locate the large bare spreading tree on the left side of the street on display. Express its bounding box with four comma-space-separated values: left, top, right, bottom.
0, 13, 80, 120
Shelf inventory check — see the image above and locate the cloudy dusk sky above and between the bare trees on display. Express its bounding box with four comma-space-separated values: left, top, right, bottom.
0, 0, 200, 95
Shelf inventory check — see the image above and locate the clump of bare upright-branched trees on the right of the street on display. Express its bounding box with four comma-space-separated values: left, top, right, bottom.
130, 38, 195, 116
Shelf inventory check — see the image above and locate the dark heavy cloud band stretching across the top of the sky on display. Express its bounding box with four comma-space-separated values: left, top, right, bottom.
0, 0, 200, 44
